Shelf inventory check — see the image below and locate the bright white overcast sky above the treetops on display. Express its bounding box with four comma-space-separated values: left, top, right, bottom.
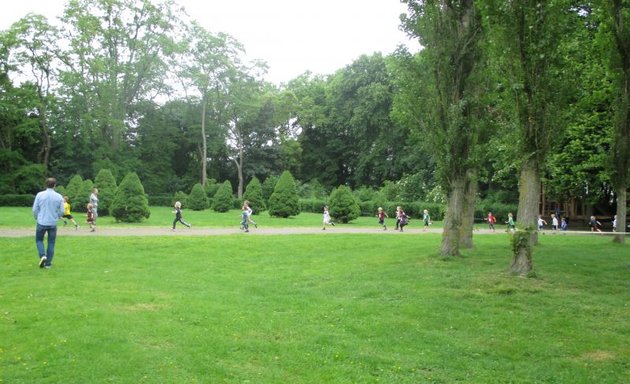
0, 0, 419, 84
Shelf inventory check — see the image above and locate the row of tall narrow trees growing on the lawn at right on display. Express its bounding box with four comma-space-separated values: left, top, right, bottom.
403, 0, 630, 273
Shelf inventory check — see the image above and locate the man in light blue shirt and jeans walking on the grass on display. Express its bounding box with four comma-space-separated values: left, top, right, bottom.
33, 177, 63, 268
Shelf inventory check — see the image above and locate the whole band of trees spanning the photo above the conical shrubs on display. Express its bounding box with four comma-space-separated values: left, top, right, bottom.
0, 0, 630, 269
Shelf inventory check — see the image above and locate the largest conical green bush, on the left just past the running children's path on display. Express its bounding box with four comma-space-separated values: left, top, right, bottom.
110, 172, 151, 223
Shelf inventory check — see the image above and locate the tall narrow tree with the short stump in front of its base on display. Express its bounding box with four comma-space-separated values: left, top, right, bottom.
480, 0, 569, 274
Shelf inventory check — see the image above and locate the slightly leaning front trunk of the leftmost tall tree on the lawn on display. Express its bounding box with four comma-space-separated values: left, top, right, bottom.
441, 176, 466, 256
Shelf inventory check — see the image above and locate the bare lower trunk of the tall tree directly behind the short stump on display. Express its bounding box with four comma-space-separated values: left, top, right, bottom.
516, 158, 540, 245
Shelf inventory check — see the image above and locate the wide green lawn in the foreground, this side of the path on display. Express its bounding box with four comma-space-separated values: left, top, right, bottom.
0, 232, 630, 383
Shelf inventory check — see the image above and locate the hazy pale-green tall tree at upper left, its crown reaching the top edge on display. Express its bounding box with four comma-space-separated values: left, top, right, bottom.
62, 0, 180, 168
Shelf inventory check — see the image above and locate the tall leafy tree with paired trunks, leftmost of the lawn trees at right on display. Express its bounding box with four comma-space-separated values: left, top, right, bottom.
403, 0, 482, 256
